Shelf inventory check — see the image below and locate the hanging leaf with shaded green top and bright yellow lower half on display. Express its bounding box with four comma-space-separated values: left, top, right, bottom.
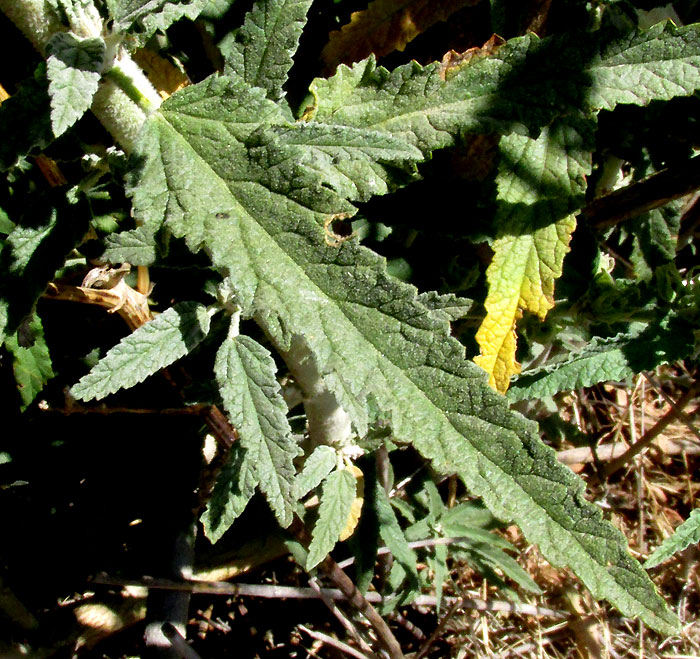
474, 121, 590, 393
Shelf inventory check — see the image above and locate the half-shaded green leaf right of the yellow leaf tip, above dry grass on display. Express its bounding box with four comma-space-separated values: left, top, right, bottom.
508, 314, 695, 401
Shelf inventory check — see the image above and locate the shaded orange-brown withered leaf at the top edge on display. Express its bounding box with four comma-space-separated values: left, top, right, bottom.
321, 0, 478, 70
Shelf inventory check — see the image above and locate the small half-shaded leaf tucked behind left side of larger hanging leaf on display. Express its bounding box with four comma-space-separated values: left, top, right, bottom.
202, 443, 258, 543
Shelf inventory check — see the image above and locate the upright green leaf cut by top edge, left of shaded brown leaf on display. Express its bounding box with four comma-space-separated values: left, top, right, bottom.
220, 0, 312, 106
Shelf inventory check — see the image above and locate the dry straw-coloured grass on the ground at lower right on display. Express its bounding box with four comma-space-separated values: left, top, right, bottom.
434, 368, 700, 659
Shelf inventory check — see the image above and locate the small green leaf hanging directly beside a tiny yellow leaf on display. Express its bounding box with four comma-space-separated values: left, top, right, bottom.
306, 469, 356, 570
